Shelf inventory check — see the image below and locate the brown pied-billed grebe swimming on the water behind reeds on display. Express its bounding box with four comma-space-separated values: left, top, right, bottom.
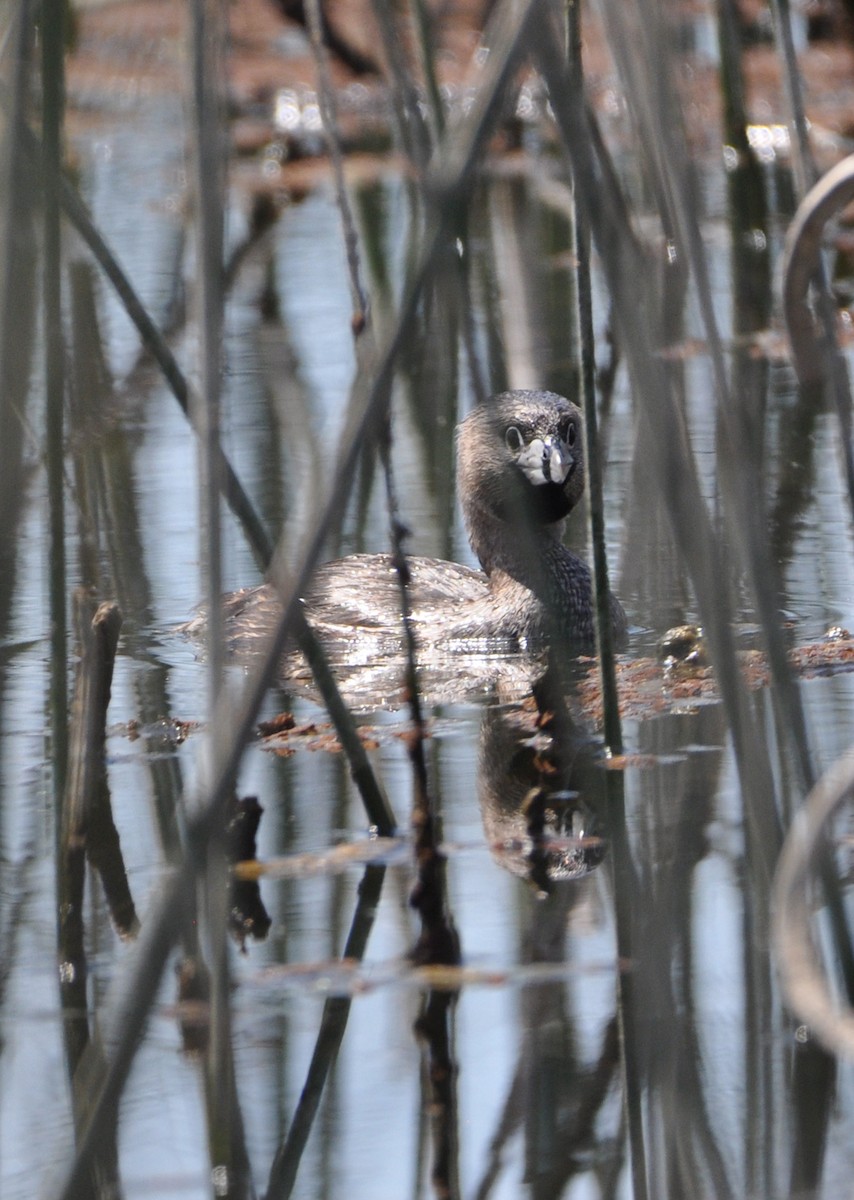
207, 391, 626, 653
